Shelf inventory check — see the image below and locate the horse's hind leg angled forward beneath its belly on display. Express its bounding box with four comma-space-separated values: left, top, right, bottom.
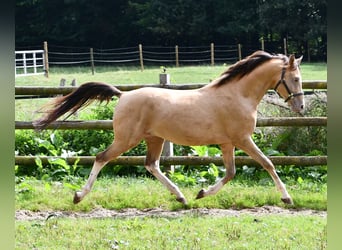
145, 137, 187, 204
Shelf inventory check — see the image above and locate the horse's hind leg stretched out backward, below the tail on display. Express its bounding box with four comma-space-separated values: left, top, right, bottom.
74, 139, 139, 204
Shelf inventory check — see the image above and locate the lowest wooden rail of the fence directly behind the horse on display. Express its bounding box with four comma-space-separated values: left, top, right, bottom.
15, 156, 328, 166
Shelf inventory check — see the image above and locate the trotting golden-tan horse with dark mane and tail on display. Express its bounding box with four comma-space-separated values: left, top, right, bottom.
33, 51, 305, 204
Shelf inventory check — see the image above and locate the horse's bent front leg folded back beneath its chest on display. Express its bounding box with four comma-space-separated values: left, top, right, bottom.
196, 143, 235, 199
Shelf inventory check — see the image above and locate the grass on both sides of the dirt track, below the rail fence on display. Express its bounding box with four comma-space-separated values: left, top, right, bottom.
15, 178, 327, 249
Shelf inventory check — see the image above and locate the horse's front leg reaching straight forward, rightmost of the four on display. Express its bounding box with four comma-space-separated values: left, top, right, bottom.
237, 137, 293, 205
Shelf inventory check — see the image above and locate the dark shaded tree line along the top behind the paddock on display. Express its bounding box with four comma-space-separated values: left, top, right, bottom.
15, 0, 327, 60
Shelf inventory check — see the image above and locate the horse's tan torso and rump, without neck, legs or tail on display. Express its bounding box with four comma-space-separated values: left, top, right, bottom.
114, 87, 235, 145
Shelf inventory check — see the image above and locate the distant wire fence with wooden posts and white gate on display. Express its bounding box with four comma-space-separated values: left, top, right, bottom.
15, 38, 306, 77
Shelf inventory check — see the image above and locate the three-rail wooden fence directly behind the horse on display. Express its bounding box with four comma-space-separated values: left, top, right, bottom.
15, 81, 327, 166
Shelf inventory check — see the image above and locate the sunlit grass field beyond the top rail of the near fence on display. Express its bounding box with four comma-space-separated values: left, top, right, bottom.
15, 63, 327, 86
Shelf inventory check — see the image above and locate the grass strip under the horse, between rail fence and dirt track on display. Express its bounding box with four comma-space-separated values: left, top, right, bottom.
16, 177, 327, 212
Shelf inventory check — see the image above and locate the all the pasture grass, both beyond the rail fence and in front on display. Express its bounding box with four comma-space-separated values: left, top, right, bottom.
15, 63, 327, 249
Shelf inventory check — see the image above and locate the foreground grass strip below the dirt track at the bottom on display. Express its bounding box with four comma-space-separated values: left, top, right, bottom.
15, 215, 327, 250
